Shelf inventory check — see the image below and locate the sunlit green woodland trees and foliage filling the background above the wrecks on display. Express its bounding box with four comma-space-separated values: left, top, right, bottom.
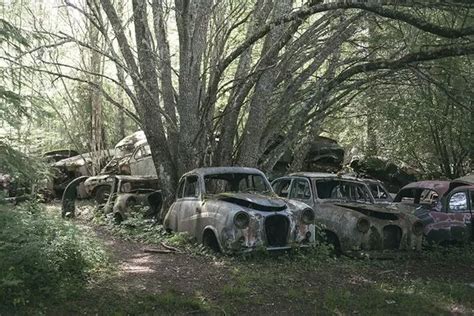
0, 0, 474, 196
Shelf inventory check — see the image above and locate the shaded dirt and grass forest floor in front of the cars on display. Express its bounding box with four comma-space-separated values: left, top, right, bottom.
2, 205, 474, 315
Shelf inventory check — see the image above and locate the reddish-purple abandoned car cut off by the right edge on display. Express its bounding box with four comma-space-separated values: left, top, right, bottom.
394, 180, 474, 244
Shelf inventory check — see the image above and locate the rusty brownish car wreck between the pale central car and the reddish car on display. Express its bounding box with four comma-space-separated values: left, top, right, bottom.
272, 173, 423, 255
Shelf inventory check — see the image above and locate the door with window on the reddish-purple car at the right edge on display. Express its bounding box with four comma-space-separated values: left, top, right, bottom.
446, 190, 472, 242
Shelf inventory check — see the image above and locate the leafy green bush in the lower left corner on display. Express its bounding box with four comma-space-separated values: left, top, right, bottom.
0, 202, 108, 313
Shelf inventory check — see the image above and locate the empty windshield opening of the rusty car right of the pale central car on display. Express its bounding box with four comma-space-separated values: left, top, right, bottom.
316, 179, 372, 202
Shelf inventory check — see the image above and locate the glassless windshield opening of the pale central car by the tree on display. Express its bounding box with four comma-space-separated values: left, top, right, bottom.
204, 173, 271, 194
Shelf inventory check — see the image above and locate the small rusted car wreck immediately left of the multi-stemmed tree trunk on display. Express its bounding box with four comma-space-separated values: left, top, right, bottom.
104, 175, 163, 223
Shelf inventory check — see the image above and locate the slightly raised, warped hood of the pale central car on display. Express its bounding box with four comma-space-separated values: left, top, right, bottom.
213, 193, 287, 212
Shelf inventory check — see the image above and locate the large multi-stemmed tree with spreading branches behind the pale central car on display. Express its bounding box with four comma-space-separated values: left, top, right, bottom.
3, 0, 474, 206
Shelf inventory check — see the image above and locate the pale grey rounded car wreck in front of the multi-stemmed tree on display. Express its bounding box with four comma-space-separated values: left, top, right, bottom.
164, 167, 315, 253
